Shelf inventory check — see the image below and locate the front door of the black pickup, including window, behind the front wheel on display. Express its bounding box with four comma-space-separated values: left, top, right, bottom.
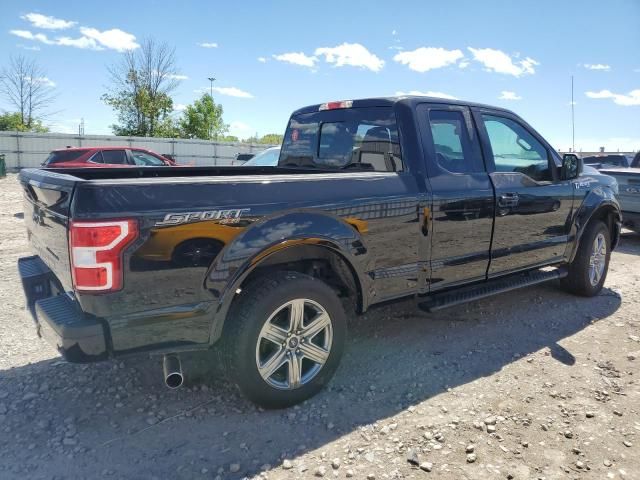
474, 110, 573, 277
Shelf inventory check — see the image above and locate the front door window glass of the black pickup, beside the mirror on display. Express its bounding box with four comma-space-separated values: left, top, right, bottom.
482, 114, 553, 182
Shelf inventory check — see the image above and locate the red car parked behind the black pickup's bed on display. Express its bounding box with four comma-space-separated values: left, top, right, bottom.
42, 147, 176, 168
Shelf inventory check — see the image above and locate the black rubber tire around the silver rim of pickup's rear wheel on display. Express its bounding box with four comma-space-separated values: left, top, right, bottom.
220, 271, 347, 408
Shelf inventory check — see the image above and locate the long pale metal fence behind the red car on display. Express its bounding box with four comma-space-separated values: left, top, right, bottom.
0, 131, 271, 170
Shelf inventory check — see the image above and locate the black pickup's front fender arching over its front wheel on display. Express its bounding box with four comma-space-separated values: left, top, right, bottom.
567, 185, 622, 262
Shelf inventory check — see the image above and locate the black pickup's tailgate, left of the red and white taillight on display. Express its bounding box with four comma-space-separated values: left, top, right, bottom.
20, 169, 81, 290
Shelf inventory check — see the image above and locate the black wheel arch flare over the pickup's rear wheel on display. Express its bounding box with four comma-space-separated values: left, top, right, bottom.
205, 210, 369, 343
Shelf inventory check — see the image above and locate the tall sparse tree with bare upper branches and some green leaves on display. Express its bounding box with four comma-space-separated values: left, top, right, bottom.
102, 38, 179, 136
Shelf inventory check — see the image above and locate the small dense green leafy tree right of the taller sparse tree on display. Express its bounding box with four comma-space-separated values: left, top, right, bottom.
180, 93, 229, 140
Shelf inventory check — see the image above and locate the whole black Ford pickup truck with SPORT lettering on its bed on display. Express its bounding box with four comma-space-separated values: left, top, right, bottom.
18, 97, 621, 407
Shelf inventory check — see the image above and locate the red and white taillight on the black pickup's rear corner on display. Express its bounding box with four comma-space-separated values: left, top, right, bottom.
69, 220, 138, 293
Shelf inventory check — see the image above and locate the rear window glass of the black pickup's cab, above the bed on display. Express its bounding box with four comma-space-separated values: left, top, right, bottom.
278, 107, 403, 172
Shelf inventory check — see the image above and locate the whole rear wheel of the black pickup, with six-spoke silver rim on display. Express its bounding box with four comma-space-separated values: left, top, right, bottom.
222, 272, 347, 408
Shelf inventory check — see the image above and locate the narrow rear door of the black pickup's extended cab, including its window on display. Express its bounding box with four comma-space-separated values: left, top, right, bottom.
417, 104, 494, 291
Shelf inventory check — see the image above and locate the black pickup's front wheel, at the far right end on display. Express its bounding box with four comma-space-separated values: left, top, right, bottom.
562, 220, 611, 297
